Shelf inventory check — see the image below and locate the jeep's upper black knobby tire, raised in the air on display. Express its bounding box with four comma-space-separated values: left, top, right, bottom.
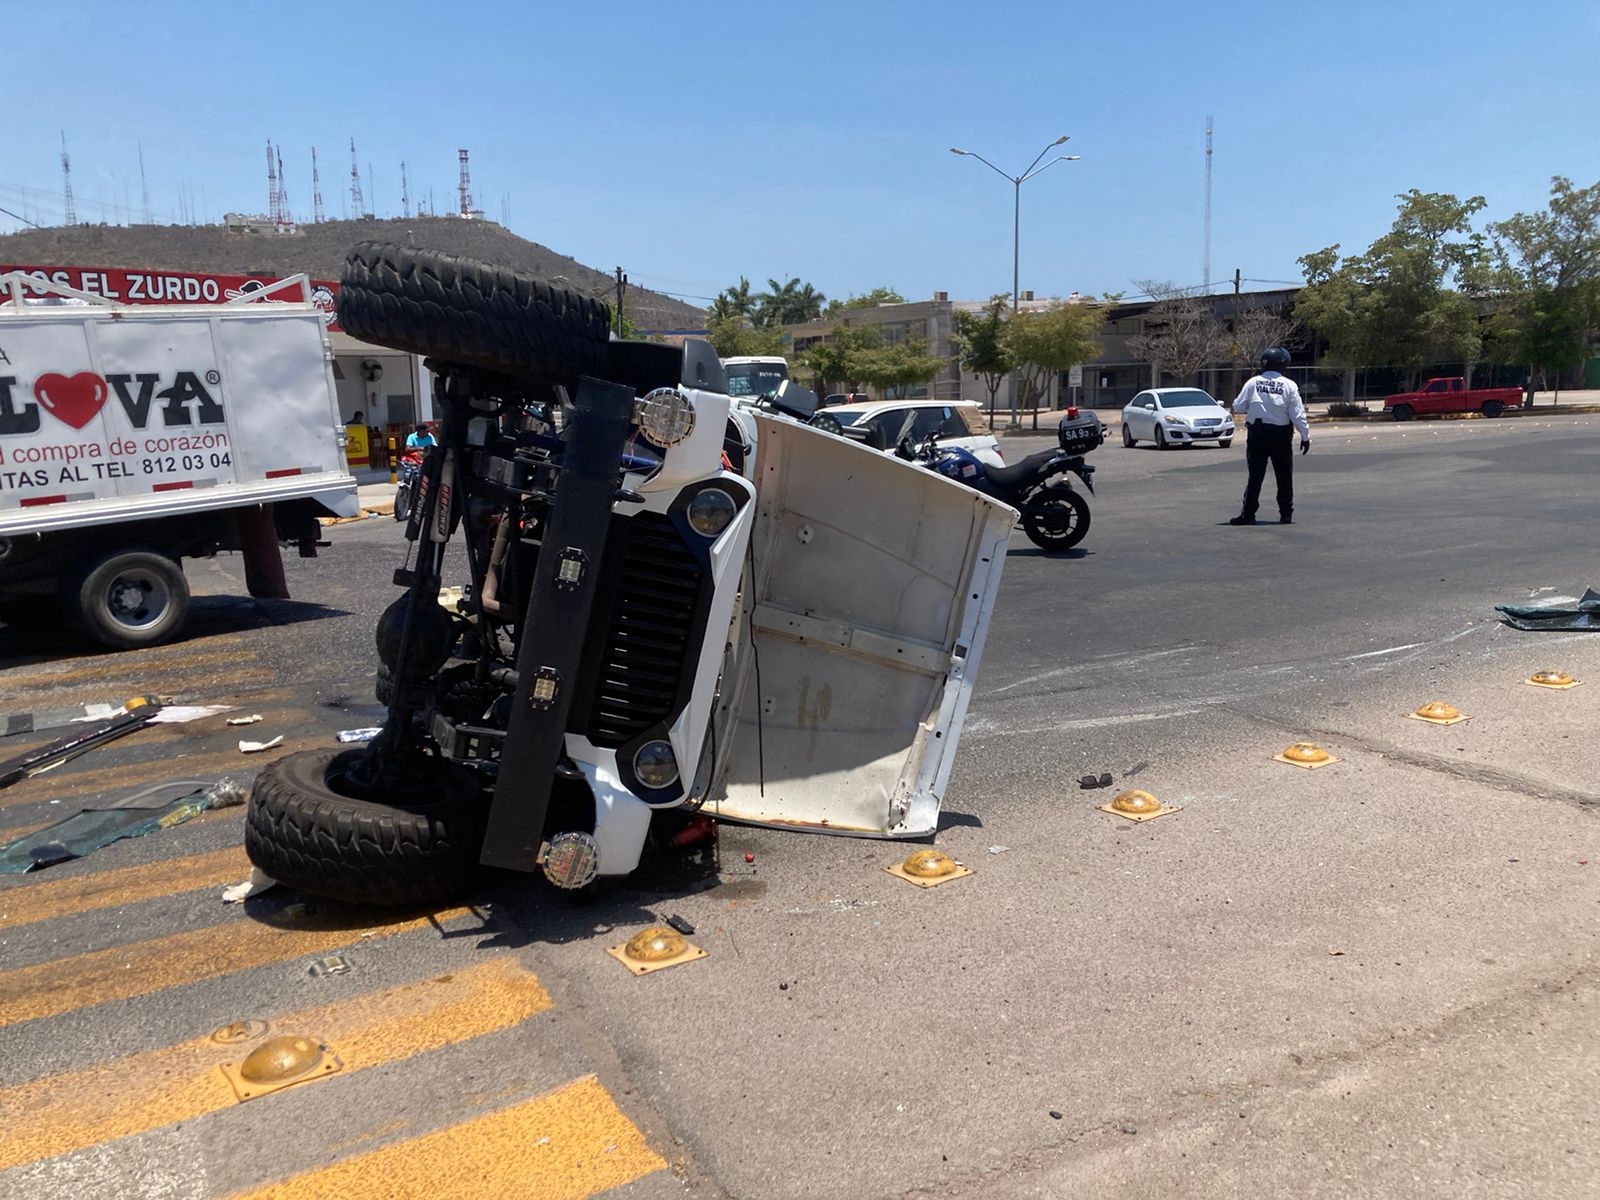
339, 242, 611, 384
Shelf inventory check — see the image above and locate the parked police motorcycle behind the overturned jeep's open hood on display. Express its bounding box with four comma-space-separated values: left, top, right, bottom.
896, 435, 1094, 554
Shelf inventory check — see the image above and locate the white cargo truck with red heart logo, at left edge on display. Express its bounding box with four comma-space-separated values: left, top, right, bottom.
0, 272, 360, 648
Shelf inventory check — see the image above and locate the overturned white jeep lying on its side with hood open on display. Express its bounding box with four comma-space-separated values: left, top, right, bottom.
246, 243, 1016, 902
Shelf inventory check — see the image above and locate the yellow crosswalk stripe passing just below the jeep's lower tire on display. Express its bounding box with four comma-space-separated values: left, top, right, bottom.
0, 909, 470, 1029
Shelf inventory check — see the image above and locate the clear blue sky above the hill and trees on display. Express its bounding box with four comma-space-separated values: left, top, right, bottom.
0, 0, 1600, 310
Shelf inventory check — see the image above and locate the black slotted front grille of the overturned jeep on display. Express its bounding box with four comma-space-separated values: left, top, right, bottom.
586, 512, 701, 749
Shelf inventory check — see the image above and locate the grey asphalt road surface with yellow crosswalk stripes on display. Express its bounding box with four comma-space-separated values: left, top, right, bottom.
0, 414, 1600, 1200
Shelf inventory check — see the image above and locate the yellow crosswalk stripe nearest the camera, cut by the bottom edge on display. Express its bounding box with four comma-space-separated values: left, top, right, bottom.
235, 1075, 667, 1200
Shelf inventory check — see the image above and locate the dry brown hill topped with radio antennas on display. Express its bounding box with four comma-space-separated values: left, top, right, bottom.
0, 216, 706, 330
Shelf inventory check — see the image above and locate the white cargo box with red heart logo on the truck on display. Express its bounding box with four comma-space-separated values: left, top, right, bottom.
0, 277, 358, 534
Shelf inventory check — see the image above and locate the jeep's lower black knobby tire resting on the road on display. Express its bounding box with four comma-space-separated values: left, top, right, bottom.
245, 749, 488, 906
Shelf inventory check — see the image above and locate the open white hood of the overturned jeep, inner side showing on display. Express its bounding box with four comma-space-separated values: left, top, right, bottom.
706, 416, 1016, 837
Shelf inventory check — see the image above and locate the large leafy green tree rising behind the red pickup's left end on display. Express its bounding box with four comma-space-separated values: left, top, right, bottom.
1294, 187, 1490, 384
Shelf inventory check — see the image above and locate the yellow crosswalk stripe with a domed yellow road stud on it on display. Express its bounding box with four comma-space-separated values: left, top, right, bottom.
0, 957, 550, 1177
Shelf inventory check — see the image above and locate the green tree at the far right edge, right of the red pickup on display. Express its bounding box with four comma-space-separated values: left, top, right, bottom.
1490, 176, 1600, 403
